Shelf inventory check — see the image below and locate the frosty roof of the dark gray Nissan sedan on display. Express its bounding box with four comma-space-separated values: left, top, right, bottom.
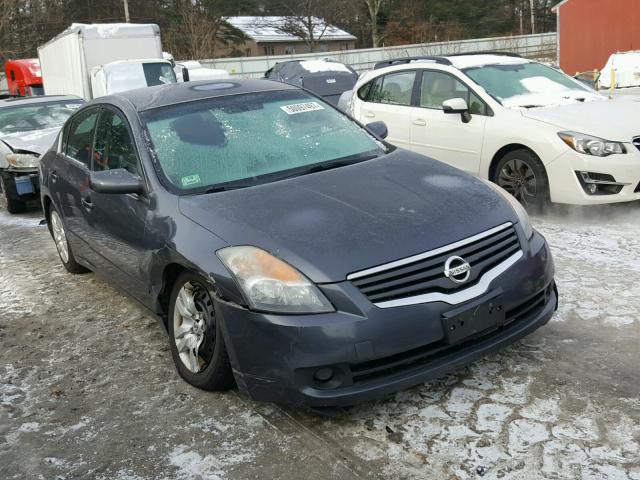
109, 78, 297, 112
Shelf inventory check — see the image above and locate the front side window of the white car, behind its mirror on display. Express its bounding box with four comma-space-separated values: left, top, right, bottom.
420, 71, 487, 115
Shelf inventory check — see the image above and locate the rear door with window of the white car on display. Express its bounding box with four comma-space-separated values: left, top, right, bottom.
355, 70, 417, 149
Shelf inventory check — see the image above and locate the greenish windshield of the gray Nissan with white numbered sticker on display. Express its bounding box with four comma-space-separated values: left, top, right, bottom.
142, 90, 384, 193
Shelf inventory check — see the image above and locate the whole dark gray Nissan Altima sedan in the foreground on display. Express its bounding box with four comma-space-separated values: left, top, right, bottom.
40, 80, 558, 406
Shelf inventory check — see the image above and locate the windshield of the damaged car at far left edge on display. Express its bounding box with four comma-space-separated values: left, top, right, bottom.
0, 100, 83, 135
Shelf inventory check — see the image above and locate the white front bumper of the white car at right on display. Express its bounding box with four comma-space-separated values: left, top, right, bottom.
546, 148, 640, 205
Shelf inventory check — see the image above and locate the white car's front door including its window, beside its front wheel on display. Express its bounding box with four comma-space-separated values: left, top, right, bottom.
410, 70, 491, 174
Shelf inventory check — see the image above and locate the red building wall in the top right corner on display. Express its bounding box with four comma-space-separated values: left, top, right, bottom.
553, 0, 640, 75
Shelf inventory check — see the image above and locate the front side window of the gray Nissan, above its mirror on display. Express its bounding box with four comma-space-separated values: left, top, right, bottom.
93, 109, 139, 175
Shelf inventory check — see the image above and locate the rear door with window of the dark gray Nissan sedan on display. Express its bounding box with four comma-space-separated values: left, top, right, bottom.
56, 107, 99, 264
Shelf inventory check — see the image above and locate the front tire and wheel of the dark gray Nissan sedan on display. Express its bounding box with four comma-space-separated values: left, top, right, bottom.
167, 273, 235, 391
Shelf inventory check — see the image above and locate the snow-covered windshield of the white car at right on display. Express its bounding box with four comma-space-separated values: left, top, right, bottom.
463, 63, 595, 107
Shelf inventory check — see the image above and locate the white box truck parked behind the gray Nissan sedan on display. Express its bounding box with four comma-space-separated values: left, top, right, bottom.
38, 23, 176, 100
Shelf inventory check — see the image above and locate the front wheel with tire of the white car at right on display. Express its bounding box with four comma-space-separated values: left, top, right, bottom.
491, 148, 549, 210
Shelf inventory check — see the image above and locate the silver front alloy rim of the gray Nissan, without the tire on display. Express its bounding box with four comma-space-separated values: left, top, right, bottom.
173, 282, 215, 373
